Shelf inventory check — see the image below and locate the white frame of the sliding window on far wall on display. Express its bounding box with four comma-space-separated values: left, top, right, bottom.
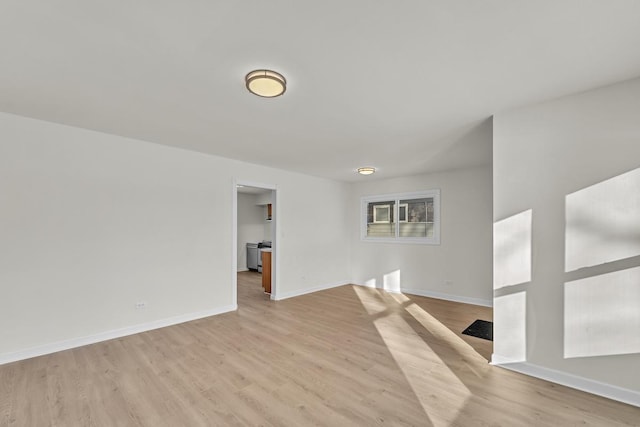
360, 189, 440, 245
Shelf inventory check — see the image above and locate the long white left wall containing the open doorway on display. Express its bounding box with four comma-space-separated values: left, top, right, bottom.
0, 114, 349, 362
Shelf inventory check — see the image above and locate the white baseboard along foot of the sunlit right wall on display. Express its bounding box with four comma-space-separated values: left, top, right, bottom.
491, 354, 640, 407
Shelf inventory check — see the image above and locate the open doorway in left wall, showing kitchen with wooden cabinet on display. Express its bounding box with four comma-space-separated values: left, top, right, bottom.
231, 180, 278, 307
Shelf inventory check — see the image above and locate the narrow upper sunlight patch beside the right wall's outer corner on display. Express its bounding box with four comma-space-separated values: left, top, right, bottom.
493, 209, 532, 290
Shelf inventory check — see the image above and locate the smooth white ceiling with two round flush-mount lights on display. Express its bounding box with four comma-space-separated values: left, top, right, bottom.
0, 0, 640, 181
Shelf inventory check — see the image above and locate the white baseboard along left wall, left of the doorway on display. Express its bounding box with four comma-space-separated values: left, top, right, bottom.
0, 305, 238, 365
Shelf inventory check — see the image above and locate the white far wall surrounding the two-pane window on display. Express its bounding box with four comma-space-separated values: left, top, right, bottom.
349, 122, 493, 305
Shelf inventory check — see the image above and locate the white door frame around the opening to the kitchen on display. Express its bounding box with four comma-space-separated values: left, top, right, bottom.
231, 178, 280, 308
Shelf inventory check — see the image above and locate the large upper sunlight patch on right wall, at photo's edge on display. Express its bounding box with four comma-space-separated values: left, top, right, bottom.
565, 168, 640, 272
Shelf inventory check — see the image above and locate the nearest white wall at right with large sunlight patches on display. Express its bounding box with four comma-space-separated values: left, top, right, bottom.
493, 75, 640, 396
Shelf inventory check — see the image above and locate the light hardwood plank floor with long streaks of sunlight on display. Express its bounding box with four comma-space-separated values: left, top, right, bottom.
0, 272, 640, 427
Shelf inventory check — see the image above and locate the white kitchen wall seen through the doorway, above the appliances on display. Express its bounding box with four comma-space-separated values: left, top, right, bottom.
237, 193, 267, 271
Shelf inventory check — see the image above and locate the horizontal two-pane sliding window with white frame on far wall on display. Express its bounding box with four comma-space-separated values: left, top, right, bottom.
361, 190, 440, 245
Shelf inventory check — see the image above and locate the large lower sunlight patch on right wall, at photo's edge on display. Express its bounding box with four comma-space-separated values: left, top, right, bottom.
564, 267, 640, 358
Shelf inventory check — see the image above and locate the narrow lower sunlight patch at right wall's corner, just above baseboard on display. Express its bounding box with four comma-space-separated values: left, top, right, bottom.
493, 291, 527, 363
